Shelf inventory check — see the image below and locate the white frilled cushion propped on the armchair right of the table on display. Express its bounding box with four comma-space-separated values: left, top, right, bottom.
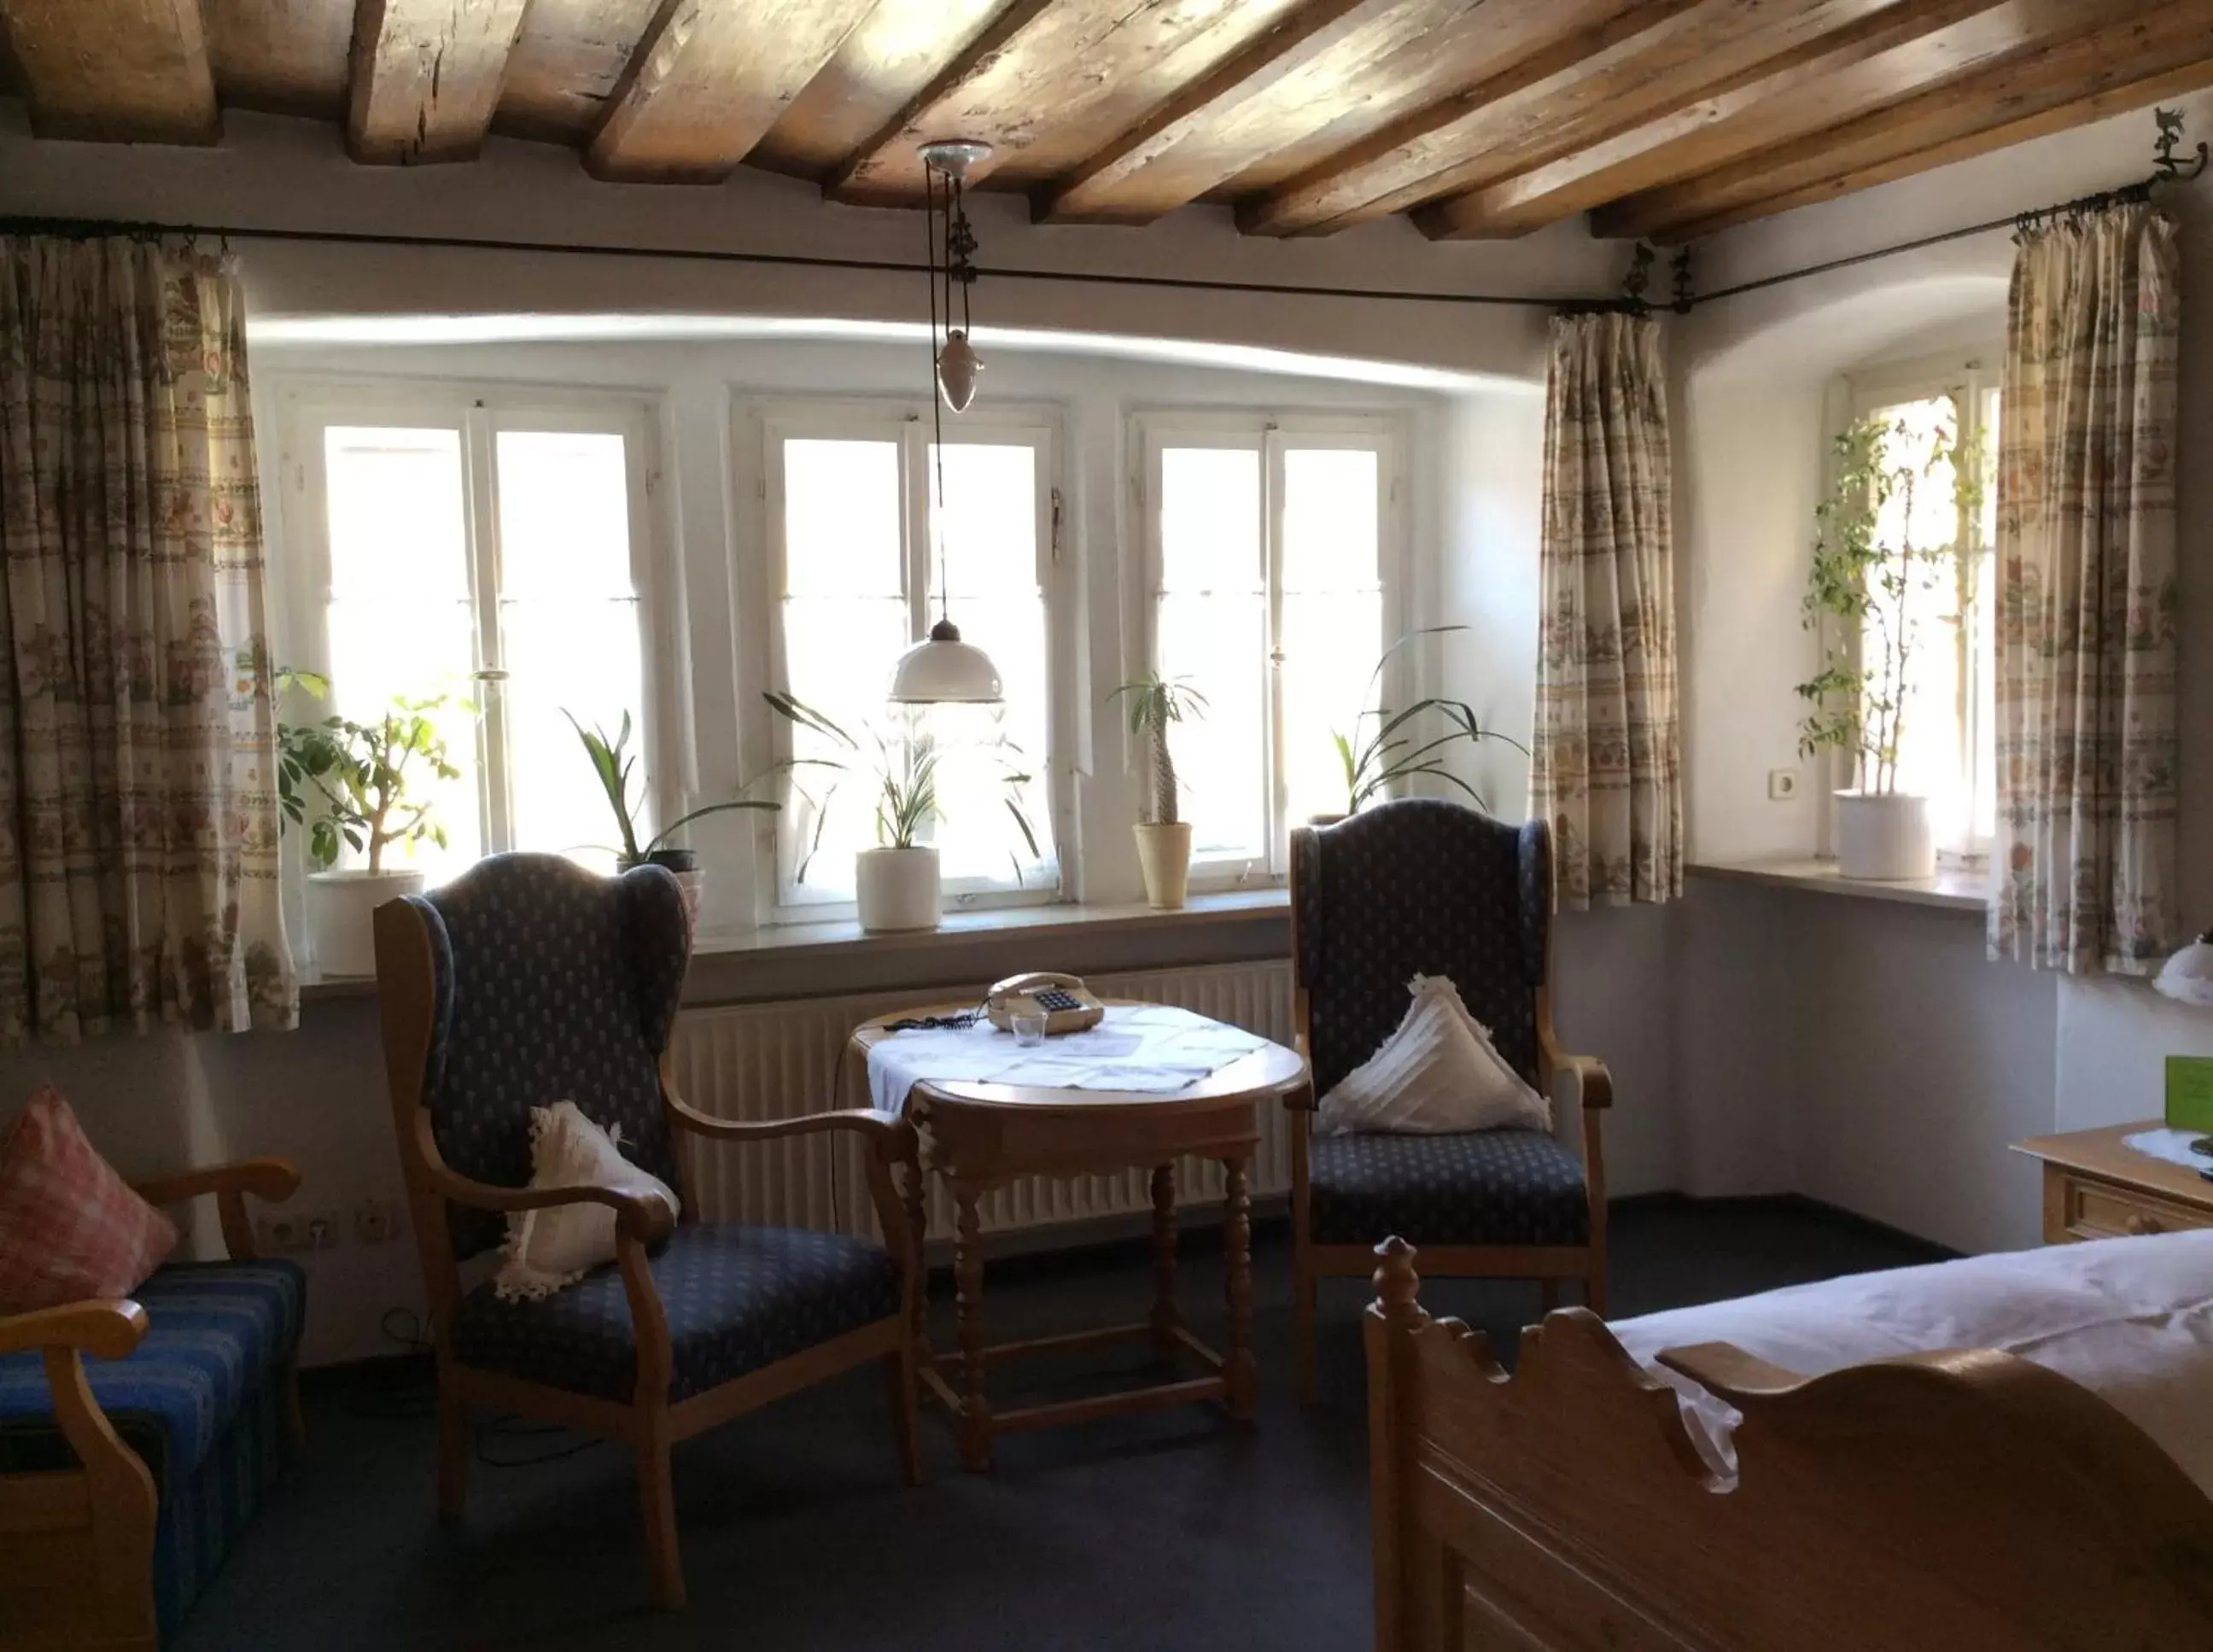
1319, 975, 1551, 1135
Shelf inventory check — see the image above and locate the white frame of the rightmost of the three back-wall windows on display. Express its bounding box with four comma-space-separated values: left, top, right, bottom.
1126, 409, 1418, 889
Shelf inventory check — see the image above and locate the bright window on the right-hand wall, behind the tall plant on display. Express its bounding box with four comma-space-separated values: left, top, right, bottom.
1853, 363, 1999, 855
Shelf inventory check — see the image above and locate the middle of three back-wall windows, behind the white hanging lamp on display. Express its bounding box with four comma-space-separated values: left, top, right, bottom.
763, 407, 1060, 909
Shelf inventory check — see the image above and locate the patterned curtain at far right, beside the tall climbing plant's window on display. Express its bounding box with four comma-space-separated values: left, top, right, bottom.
1989, 203, 2182, 975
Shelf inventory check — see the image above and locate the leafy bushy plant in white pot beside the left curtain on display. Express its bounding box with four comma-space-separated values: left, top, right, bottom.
277, 670, 463, 975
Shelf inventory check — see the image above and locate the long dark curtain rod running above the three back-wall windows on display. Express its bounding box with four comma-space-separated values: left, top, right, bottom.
0, 217, 1574, 310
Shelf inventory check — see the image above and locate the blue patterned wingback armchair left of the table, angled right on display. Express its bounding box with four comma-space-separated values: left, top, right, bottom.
377, 854, 923, 1608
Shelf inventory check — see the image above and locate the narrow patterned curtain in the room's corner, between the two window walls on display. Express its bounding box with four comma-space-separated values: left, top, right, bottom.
1529, 314, 1682, 907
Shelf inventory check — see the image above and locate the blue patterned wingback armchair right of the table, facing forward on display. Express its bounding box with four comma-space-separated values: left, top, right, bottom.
1290, 798, 1614, 1396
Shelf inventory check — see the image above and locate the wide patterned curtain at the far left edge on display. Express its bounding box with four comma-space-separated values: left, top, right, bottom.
0, 236, 299, 1046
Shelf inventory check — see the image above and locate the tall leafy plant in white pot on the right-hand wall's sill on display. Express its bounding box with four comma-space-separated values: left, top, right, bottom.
1797, 416, 1974, 880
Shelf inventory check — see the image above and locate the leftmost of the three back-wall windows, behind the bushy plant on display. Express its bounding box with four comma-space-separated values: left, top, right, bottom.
283, 387, 657, 880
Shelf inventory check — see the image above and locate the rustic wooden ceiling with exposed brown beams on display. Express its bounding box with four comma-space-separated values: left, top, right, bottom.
0, 0, 2213, 243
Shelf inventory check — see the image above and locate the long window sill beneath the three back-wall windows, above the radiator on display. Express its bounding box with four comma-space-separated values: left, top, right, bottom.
299, 889, 1290, 1004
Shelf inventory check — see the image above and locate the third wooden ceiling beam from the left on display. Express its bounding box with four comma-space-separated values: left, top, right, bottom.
584, 0, 874, 184
